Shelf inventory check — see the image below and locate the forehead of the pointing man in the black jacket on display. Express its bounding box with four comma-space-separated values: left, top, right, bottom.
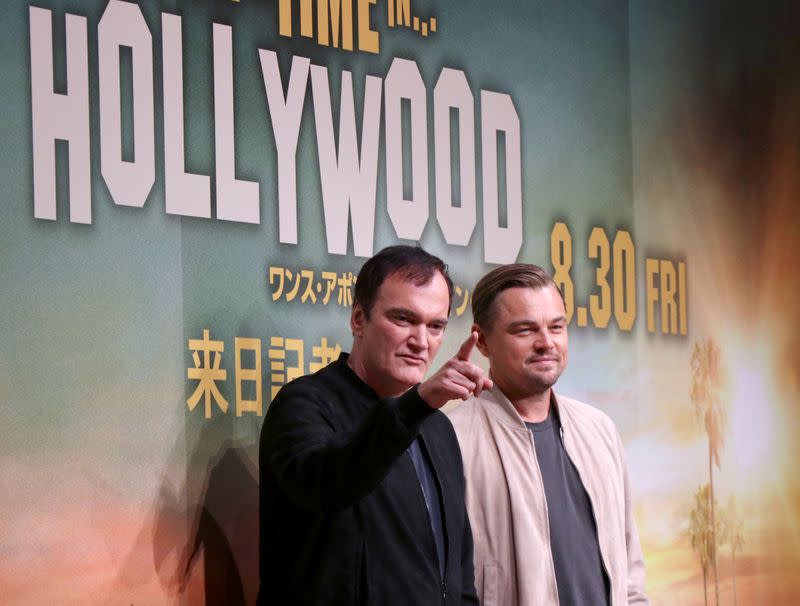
375, 271, 450, 318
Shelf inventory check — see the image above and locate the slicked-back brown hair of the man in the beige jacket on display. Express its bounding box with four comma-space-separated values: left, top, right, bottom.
472, 263, 564, 330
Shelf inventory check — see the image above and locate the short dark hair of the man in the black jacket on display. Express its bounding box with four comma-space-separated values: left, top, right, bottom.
353, 245, 453, 318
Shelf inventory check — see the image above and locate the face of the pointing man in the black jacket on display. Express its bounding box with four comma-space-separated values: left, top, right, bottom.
348, 272, 450, 397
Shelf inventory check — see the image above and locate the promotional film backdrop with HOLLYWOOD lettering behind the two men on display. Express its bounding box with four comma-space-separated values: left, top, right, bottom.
0, 0, 800, 606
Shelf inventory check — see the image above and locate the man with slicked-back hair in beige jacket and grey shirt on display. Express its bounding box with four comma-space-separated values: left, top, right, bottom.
450, 263, 649, 606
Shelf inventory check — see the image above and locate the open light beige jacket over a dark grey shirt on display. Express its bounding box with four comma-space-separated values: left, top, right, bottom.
449, 387, 650, 606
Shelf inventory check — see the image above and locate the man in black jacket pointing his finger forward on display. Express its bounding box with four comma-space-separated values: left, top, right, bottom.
258, 246, 491, 606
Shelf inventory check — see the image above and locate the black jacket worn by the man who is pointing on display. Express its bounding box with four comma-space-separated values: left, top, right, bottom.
258, 354, 478, 606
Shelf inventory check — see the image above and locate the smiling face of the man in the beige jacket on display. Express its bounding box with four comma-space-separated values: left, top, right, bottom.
477, 286, 568, 402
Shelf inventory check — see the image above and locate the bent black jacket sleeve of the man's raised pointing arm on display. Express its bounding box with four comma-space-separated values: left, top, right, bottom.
259, 382, 434, 511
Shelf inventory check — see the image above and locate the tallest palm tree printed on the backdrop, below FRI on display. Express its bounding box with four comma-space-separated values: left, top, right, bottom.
691, 339, 727, 606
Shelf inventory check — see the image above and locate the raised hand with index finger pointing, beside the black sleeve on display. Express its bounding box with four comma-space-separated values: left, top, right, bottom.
419, 331, 492, 408
